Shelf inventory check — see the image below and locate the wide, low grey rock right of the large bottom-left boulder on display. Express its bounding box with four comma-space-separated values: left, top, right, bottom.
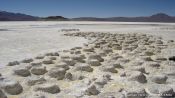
34, 84, 60, 94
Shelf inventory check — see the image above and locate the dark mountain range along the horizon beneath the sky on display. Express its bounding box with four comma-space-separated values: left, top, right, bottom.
0, 11, 175, 22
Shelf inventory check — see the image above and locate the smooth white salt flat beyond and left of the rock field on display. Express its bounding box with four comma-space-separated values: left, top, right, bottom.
0, 21, 175, 67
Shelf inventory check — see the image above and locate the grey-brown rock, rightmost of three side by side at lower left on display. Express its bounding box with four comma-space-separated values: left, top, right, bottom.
48, 68, 66, 80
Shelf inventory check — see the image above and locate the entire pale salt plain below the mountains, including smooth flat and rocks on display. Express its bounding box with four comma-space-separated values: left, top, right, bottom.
0, 21, 175, 98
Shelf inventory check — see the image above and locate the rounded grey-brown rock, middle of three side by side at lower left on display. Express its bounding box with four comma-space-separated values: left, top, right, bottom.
30, 66, 47, 75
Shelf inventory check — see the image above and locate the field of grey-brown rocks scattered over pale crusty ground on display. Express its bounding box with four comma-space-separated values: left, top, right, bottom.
0, 32, 175, 98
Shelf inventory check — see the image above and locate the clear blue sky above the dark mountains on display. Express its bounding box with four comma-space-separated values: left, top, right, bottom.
0, 0, 175, 18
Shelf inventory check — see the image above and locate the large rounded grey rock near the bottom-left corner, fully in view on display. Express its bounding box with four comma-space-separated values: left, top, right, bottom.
3, 81, 23, 95
